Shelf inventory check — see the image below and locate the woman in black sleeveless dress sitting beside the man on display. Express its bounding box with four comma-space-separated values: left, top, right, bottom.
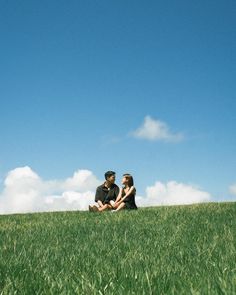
110, 173, 137, 212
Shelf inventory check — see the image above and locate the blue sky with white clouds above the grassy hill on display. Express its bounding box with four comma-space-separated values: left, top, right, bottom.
0, 0, 236, 213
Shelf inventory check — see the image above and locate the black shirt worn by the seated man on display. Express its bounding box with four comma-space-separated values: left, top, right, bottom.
95, 183, 120, 204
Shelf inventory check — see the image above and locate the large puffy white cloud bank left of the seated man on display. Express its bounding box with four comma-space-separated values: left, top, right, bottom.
0, 166, 100, 214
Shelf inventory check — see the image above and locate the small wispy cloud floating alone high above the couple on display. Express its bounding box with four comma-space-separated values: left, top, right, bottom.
132, 116, 183, 142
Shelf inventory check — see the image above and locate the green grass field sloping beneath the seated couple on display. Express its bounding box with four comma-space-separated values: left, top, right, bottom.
0, 203, 236, 295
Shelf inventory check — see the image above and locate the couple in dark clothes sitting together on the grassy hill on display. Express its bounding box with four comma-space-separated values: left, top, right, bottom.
89, 171, 137, 212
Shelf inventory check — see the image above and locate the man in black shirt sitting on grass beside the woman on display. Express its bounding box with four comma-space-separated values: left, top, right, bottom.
89, 171, 119, 212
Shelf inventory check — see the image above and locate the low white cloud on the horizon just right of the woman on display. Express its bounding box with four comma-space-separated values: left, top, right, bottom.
137, 181, 211, 206
